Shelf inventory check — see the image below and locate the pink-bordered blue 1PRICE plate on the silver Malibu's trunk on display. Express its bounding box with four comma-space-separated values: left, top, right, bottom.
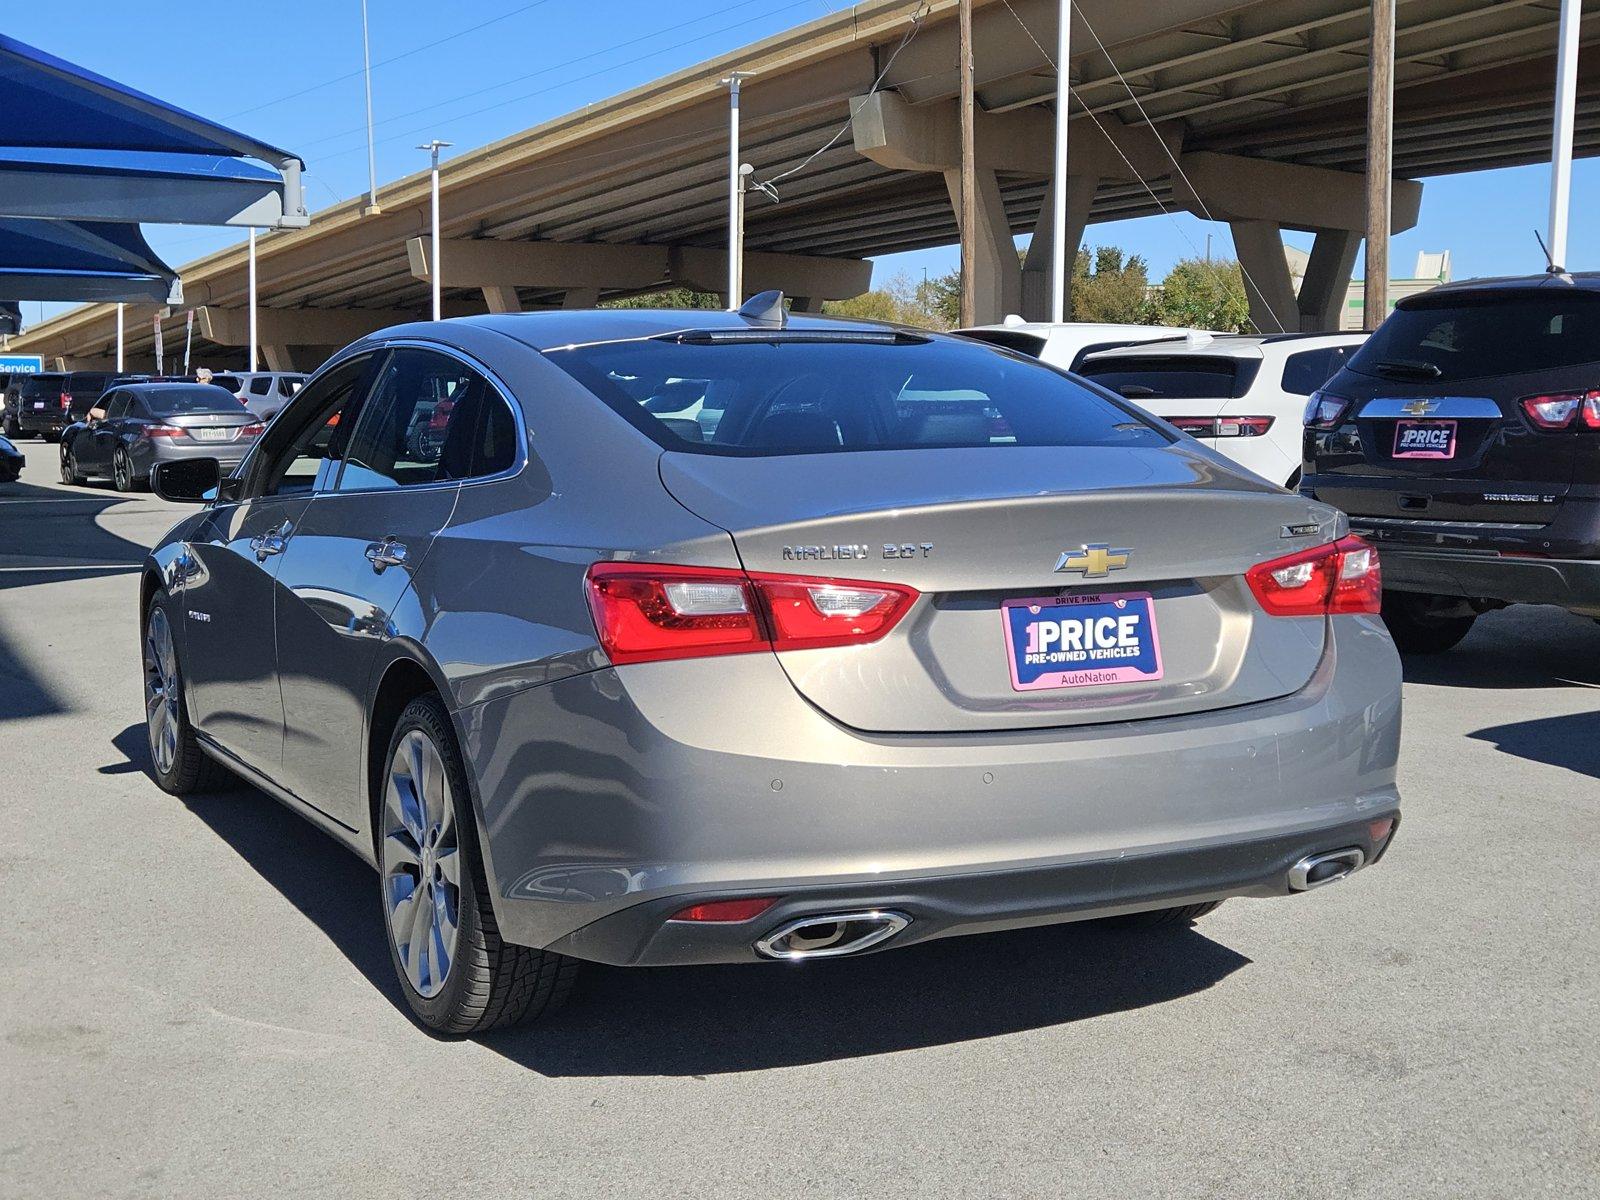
1000, 592, 1165, 691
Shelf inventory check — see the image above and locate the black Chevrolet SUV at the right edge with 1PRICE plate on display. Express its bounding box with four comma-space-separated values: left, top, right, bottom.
1301, 274, 1600, 653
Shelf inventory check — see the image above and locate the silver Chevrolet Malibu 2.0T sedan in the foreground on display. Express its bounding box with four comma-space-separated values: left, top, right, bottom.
139, 296, 1400, 1034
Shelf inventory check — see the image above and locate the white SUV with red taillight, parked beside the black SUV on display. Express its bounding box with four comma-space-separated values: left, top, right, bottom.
1078, 333, 1366, 490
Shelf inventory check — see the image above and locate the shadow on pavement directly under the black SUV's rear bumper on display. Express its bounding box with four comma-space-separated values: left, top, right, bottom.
1402, 605, 1600, 688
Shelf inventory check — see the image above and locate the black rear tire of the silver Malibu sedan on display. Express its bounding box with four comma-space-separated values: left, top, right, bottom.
374, 696, 578, 1035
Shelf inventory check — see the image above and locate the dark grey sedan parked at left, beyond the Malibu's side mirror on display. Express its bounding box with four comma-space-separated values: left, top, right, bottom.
61, 384, 264, 491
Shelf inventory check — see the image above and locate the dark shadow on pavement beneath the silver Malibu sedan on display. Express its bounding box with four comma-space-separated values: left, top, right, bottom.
112, 725, 1250, 1077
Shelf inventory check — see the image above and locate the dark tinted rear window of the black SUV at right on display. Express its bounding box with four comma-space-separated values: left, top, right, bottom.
1350, 288, 1600, 381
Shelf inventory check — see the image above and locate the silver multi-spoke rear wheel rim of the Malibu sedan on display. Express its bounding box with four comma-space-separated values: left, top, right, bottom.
382, 730, 461, 997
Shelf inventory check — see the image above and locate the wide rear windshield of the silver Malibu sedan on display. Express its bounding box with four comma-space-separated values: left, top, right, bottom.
549, 334, 1170, 456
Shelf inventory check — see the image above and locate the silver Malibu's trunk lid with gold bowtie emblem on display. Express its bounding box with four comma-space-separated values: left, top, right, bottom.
661, 445, 1339, 733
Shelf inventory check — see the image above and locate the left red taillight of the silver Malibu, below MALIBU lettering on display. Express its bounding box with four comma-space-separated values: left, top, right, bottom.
587, 563, 917, 664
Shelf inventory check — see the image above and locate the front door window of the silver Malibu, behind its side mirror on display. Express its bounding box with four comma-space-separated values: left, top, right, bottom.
248, 355, 373, 496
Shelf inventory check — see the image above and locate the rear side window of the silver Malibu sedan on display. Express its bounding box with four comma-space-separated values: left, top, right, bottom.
338, 347, 488, 491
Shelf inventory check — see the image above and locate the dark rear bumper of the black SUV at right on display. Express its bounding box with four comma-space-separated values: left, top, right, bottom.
1379, 542, 1600, 613
